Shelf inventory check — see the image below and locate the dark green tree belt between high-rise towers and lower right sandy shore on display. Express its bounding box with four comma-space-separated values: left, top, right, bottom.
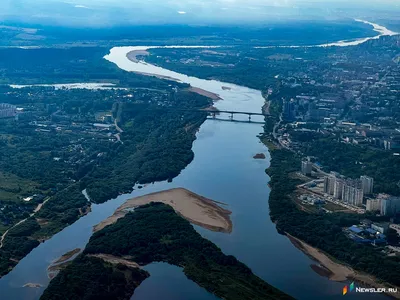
267, 150, 400, 285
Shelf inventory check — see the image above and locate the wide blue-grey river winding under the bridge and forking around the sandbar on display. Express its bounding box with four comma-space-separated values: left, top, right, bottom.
0, 40, 394, 300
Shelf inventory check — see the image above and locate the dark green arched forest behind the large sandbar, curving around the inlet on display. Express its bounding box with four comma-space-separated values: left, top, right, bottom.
41, 203, 291, 300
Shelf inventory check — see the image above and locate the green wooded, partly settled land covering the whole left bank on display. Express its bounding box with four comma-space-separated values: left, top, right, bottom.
0, 48, 211, 275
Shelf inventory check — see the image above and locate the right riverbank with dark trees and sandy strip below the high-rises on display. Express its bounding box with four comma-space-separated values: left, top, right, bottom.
267, 145, 400, 298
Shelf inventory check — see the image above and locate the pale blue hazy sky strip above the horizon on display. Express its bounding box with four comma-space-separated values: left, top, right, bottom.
0, 0, 400, 27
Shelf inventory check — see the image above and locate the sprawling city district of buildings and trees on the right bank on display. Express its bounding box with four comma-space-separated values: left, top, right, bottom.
267, 38, 400, 255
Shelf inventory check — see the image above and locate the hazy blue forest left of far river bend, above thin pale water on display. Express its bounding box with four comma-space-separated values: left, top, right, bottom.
0, 47, 186, 89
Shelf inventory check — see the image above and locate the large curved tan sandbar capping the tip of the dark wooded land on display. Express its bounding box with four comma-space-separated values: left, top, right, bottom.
94, 188, 232, 233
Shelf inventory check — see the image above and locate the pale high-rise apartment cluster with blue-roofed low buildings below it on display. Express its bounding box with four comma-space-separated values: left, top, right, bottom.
298, 158, 400, 255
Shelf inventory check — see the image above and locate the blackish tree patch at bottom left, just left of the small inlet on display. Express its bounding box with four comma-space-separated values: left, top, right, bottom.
40, 255, 149, 300
